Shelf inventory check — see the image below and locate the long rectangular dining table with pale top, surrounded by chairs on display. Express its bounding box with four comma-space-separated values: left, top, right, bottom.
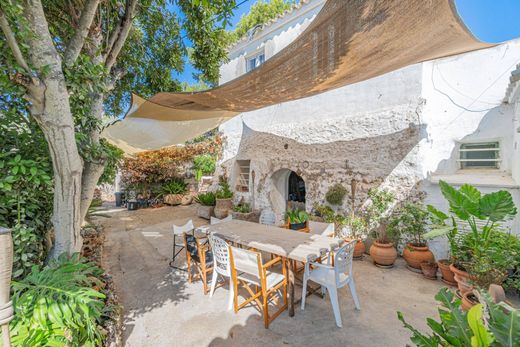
199, 220, 344, 317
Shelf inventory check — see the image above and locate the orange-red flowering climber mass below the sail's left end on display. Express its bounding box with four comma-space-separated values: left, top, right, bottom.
121, 136, 222, 186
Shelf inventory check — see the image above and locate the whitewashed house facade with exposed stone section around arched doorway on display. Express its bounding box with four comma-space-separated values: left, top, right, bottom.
220, 0, 520, 257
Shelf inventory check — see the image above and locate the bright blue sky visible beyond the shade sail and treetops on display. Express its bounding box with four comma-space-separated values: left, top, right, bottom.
177, 0, 520, 83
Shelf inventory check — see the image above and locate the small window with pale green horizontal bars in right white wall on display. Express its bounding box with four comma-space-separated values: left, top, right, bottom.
459, 142, 500, 169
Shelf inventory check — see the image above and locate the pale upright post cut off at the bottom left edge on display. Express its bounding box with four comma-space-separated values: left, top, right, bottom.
0, 227, 14, 347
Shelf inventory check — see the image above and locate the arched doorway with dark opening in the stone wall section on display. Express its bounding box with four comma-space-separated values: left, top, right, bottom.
269, 169, 306, 218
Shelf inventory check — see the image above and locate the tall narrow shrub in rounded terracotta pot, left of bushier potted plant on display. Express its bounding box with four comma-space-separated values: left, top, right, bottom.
364, 189, 399, 267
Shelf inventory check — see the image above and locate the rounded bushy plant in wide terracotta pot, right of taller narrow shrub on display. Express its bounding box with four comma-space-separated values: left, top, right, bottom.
388, 203, 435, 272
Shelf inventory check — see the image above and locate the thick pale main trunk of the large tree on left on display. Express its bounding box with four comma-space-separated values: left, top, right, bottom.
24, 0, 83, 258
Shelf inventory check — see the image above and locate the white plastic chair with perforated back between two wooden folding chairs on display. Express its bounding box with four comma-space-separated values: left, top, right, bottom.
208, 233, 233, 310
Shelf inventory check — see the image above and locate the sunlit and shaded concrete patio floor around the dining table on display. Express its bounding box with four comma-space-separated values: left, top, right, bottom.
95, 205, 443, 347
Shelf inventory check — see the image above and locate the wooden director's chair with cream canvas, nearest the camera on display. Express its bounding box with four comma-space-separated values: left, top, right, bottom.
229, 246, 287, 329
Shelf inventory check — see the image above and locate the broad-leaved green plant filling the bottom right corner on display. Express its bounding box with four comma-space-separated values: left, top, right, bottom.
397, 288, 520, 347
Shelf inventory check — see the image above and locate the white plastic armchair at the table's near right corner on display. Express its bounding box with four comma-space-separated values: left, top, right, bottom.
302, 241, 361, 328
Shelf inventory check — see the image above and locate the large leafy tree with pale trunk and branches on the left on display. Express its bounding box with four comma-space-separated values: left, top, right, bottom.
0, 0, 235, 257
